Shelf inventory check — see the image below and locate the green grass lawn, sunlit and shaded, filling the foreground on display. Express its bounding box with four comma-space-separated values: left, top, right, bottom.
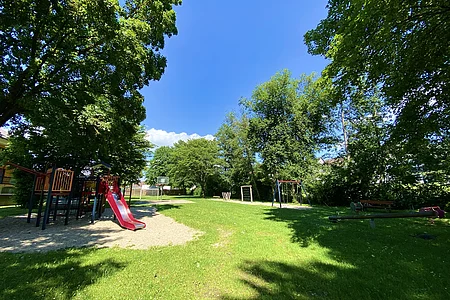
0, 199, 450, 299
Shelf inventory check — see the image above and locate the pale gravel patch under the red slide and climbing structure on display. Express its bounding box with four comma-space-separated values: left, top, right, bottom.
0, 203, 203, 253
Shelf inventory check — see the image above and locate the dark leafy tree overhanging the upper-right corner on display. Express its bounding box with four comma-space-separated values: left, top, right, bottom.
305, 0, 450, 140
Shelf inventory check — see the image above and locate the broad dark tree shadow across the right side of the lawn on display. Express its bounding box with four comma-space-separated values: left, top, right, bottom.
237, 208, 450, 299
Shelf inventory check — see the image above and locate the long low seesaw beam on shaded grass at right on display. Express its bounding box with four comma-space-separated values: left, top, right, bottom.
328, 206, 445, 228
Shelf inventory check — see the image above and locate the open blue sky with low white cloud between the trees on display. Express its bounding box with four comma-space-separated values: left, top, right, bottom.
142, 0, 327, 146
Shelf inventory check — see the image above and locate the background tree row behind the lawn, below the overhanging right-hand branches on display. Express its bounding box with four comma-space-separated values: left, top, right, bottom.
146, 63, 450, 208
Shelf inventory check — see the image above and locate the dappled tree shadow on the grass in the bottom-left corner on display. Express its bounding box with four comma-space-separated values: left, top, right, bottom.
0, 249, 125, 299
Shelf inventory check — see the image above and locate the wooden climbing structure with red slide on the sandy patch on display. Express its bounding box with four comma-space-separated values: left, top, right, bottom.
6, 162, 145, 230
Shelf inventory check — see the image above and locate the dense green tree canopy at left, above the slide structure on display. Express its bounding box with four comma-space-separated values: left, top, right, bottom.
0, 0, 181, 204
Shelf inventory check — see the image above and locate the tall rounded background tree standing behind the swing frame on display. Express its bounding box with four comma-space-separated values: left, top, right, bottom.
241, 70, 329, 180
